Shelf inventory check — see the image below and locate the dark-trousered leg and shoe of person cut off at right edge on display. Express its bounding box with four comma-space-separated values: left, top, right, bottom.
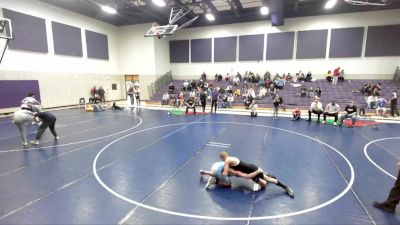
373, 162, 400, 213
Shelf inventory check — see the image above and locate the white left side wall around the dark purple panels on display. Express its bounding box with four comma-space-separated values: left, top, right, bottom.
0, 0, 125, 113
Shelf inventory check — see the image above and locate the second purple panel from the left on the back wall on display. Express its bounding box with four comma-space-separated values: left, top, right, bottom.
190, 38, 211, 62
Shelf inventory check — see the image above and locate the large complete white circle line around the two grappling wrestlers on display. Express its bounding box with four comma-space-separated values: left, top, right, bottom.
93, 122, 355, 221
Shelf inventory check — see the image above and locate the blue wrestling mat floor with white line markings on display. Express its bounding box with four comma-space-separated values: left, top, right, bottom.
0, 109, 400, 225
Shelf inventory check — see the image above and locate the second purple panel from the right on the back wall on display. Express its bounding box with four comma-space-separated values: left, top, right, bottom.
329, 27, 364, 58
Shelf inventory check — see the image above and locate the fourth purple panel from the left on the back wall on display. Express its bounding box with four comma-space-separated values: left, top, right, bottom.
239, 34, 264, 61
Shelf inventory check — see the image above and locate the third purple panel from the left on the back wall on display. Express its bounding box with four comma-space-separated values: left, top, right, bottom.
214, 37, 237, 62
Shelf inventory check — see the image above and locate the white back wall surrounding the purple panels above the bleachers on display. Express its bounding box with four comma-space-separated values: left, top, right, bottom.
171, 10, 400, 79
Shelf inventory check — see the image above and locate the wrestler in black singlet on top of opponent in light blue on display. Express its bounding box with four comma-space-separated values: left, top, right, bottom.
219, 151, 294, 198
